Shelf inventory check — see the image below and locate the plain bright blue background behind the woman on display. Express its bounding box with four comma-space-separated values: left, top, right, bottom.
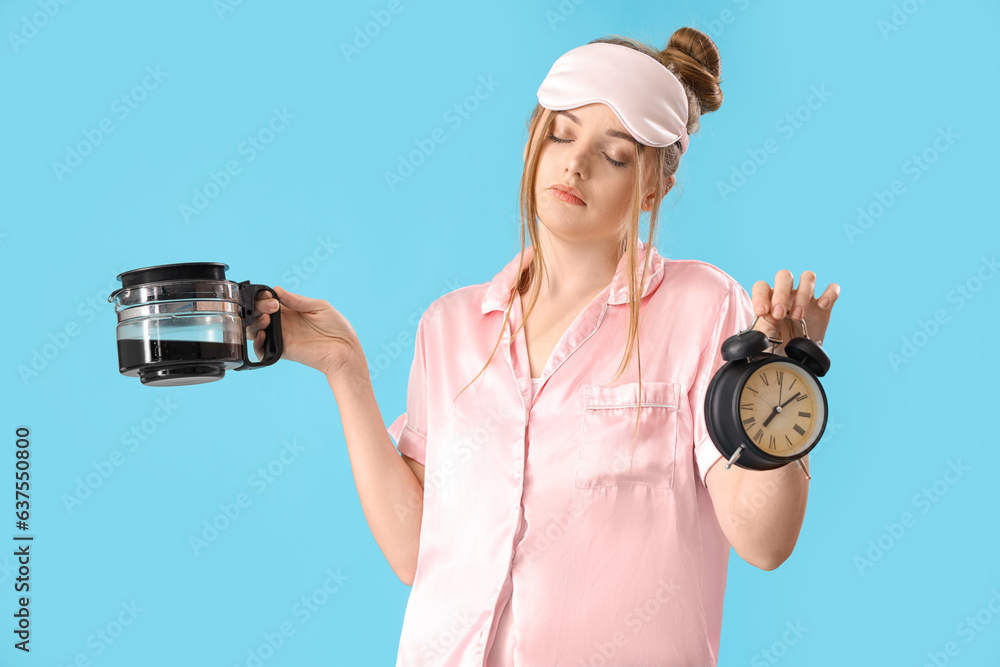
0, 0, 1000, 667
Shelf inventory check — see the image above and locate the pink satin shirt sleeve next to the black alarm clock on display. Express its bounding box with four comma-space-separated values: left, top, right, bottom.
688, 282, 754, 486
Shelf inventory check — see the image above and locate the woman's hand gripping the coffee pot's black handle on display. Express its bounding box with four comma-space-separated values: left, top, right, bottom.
246, 286, 361, 376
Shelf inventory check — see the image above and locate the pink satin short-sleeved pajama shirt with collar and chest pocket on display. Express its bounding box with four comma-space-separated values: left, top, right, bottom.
388, 242, 753, 667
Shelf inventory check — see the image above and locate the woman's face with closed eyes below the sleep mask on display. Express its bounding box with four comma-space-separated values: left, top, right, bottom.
535, 102, 651, 247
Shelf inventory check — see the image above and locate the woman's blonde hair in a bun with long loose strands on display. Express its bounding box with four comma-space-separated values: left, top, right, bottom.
455, 27, 722, 462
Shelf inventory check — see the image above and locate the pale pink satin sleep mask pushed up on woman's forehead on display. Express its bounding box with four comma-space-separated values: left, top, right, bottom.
538, 42, 688, 153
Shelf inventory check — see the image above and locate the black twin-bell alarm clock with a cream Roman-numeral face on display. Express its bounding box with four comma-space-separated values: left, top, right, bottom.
705, 315, 830, 478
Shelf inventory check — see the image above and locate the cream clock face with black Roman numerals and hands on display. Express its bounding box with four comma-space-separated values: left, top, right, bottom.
739, 361, 826, 456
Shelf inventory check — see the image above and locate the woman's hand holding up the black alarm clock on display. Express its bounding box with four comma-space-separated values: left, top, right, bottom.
751, 269, 840, 354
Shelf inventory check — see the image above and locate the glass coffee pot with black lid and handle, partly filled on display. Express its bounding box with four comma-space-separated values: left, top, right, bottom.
108, 262, 282, 387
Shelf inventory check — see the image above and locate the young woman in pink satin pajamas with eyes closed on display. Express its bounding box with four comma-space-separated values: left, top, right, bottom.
248, 28, 840, 667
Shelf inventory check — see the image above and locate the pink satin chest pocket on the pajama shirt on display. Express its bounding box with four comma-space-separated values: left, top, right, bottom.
576, 380, 680, 490
